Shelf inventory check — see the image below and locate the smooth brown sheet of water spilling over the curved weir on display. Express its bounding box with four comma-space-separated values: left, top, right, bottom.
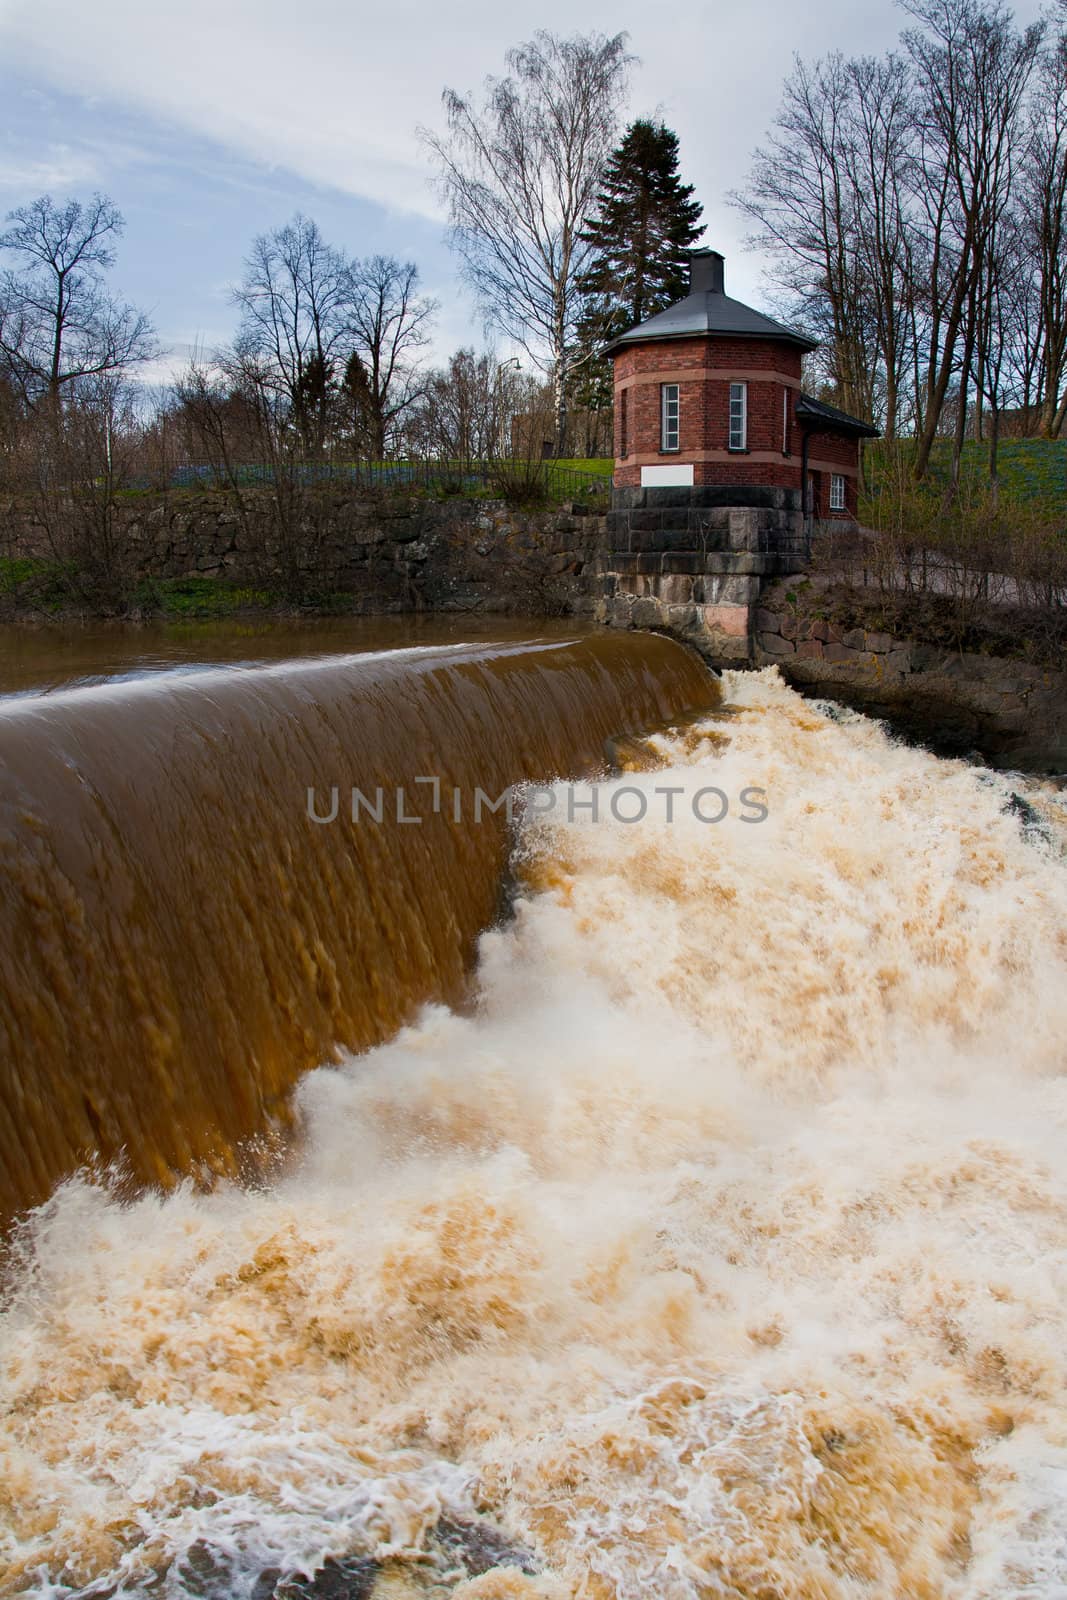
0, 635, 717, 1214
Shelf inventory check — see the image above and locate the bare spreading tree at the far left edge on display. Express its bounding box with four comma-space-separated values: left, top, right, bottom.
0, 195, 157, 406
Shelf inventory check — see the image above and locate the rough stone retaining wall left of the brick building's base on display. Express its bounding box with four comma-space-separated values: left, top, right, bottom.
0, 491, 605, 614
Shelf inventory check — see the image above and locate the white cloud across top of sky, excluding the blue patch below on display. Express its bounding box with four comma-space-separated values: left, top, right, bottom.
0, 0, 1038, 313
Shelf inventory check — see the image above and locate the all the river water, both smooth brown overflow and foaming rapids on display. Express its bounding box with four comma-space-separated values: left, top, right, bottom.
0, 622, 1067, 1600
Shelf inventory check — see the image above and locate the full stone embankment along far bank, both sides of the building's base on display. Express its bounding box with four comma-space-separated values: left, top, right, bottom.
0, 488, 1067, 773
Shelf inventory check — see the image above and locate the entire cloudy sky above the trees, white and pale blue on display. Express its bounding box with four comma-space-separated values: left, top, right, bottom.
0, 0, 1037, 380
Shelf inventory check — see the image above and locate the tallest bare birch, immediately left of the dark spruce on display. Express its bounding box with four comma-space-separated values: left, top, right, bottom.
422, 30, 632, 451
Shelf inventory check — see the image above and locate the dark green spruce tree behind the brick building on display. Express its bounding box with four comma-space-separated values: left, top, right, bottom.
573, 118, 704, 406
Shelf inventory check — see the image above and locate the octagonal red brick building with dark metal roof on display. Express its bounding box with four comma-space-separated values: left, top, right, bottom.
608, 250, 878, 520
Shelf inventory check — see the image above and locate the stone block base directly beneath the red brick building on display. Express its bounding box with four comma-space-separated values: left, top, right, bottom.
595, 485, 808, 666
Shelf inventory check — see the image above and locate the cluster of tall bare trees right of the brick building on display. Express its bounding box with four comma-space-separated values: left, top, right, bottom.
733, 0, 1067, 467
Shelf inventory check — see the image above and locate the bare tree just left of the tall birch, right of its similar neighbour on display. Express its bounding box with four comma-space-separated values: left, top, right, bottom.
344, 256, 437, 461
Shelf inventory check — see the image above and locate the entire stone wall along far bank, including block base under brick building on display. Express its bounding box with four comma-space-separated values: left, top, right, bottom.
10, 488, 1067, 771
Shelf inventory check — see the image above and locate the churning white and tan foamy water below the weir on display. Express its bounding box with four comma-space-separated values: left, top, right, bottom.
0, 656, 1067, 1600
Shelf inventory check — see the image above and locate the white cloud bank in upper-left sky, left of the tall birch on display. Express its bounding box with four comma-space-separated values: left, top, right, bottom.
0, 0, 454, 214
